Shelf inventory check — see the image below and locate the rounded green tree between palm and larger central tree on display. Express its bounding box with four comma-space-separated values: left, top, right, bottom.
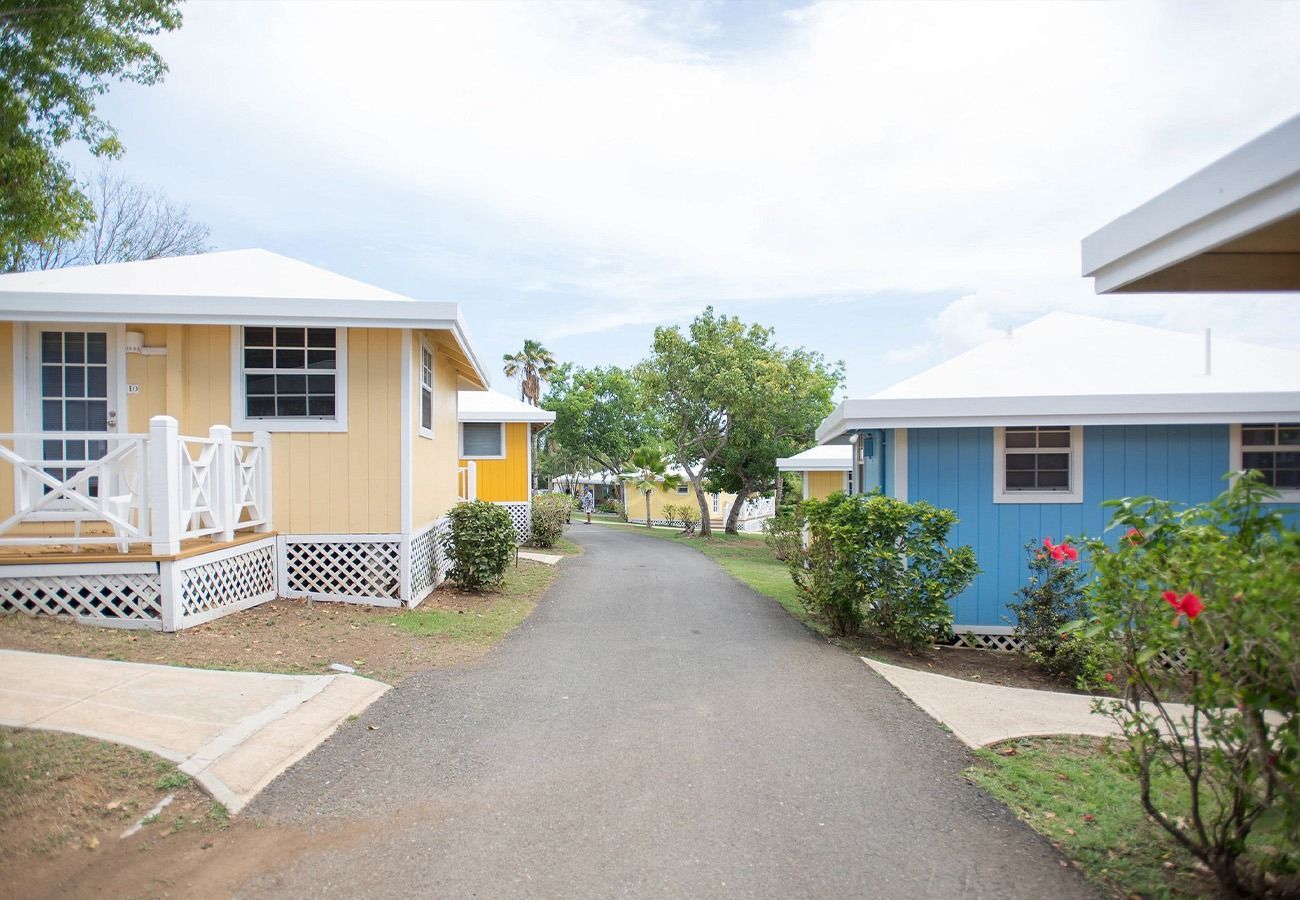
542, 365, 651, 507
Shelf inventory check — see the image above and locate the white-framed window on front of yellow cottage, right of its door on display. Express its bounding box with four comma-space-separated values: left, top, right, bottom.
233, 326, 347, 430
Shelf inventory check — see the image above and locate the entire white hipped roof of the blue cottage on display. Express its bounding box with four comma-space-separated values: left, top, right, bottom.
816, 312, 1300, 442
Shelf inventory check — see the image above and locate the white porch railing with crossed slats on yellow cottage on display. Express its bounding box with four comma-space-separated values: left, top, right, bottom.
0, 416, 270, 555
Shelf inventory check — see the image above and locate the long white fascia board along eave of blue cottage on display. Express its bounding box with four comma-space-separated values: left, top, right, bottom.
816, 390, 1300, 443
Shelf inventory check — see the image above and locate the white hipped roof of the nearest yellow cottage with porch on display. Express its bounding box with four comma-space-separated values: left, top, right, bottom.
0, 250, 488, 384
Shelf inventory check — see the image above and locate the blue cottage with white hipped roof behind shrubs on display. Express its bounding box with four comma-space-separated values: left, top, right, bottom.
816, 312, 1300, 646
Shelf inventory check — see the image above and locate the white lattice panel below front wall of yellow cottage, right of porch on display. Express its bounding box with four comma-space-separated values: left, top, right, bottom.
285, 540, 402, 600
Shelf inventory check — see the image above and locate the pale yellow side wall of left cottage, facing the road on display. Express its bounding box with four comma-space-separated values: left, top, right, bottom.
411, 332, 460, 529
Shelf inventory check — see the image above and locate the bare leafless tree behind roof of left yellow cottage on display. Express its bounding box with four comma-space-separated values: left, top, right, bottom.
18, 160, 209, 269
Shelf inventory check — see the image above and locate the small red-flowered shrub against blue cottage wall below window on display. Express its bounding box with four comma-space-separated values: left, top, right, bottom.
1010, 538, 1106, 691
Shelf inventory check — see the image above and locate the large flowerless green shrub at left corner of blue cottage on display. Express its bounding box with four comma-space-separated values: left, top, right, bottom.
789, 493, 979, 649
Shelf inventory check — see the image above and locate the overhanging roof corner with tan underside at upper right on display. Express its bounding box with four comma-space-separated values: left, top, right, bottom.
1083, 110, 1300, 294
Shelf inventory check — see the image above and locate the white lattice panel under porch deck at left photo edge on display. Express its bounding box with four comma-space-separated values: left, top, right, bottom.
0, 571, 163, 622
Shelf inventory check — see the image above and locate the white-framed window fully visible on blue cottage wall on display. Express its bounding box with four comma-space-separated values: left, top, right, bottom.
993, 425, 1083, 503
